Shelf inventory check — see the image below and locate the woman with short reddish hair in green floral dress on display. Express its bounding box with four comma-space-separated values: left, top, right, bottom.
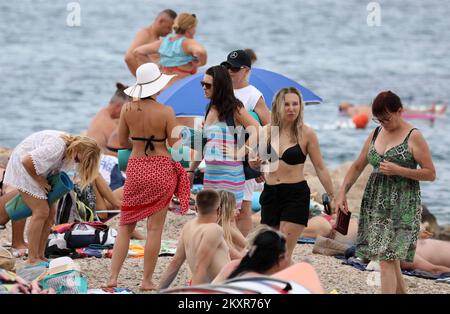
336, 91, 436, 293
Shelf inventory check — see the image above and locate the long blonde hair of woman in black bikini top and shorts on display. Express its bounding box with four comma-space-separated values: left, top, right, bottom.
269, 87, 305, 143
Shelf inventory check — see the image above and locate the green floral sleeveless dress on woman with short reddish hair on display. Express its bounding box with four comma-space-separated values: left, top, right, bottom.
356, 127, 422, 262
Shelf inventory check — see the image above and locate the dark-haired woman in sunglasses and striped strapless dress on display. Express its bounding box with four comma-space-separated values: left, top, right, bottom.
189, 66, 259, 209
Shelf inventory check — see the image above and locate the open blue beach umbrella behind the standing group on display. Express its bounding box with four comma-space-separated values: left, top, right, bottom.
158, 68, 322, 116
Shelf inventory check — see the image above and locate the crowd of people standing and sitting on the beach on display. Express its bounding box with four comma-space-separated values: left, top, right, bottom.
0, 9, 450, 293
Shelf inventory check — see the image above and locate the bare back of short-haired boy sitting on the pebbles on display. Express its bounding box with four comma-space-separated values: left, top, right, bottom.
182, 219, 230, 282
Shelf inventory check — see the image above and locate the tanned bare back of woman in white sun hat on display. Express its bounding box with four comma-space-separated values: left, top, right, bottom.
119, 99, 175, 157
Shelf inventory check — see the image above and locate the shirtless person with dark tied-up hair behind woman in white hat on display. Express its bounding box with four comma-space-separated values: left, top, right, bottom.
86, 83, 128, 156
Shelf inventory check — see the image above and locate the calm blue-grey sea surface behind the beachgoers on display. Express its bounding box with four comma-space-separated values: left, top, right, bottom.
0, 0, 450, 223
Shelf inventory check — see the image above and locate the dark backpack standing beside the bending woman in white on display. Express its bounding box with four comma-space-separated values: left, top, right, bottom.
55, 191, 99, 225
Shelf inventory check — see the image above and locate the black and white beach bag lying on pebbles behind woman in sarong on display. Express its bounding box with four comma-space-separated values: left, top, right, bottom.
64, 223, 117, 249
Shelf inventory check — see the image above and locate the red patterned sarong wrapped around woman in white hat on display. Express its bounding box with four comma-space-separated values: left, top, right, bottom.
120, 156, 190, 225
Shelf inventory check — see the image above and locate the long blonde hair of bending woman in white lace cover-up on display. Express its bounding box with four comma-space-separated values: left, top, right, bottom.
61, 134, 101, 189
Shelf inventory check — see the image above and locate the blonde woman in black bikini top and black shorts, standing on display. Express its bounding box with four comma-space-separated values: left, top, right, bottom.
251, 87, 333, 262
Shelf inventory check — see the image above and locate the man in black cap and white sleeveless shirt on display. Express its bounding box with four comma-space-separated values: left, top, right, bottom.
221, 50, 270, 236
